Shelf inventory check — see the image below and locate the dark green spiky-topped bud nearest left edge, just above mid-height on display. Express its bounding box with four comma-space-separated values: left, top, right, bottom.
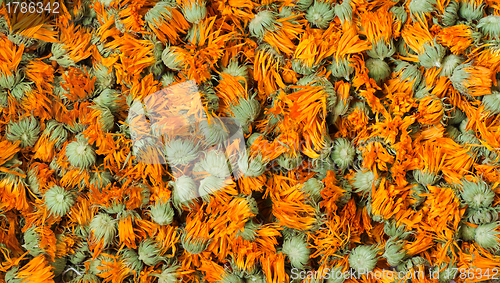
5, 117, 40, 147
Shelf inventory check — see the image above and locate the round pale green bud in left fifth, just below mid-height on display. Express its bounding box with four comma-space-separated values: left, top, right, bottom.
66, 135, 96, 169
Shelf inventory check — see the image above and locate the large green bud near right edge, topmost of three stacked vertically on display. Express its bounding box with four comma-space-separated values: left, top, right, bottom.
461, 180, 495, 211
